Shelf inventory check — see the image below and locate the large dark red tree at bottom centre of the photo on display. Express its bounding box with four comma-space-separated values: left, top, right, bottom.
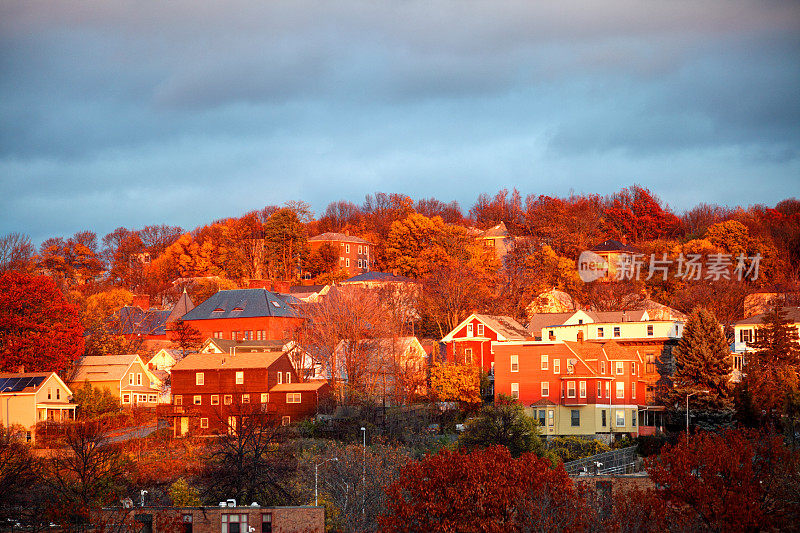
378, 446, 589, 532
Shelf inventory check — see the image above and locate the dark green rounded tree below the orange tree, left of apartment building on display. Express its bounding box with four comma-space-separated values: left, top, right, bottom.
458, 394, 544, 457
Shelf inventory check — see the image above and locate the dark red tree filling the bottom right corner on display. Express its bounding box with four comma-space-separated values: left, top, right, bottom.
649, 430, 800, 531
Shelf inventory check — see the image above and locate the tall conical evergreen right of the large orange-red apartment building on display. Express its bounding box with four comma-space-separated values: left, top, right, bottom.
672, 307, 732, 410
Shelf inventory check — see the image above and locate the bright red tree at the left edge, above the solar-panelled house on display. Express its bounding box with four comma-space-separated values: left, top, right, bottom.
0, 272, 83, 372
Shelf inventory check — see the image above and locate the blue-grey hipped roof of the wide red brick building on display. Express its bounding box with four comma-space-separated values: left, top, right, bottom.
183, 289, 298, 320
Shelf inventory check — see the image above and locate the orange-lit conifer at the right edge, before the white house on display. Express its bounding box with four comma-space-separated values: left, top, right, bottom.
745, 303, 800, 419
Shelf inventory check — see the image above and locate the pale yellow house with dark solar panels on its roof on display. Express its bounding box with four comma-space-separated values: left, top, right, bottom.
0, 372, 76, 441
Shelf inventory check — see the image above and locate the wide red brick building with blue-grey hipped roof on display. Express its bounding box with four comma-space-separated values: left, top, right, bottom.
183, 289, 303, 340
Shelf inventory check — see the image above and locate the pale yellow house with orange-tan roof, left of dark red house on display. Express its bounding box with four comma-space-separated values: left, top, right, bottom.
69, 354, 162, 407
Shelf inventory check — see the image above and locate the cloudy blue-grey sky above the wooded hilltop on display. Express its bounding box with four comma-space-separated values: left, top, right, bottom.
0, 0, 800, 242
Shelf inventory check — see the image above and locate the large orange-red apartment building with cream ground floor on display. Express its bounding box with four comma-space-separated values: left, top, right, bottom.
494, 341, 652, 440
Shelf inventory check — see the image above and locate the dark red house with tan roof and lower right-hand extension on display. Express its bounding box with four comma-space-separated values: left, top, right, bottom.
169, 351, 330, 436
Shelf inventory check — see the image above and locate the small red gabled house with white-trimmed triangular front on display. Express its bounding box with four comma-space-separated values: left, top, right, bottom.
442, 314, 530, 374
